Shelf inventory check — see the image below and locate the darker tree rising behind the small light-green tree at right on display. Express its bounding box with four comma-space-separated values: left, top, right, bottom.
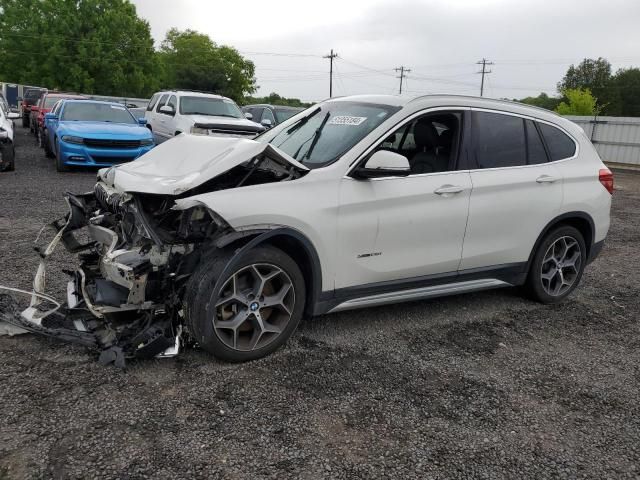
558, 57, 611, 111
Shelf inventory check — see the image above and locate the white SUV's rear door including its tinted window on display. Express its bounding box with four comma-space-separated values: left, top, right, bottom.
460, 110, 563, 273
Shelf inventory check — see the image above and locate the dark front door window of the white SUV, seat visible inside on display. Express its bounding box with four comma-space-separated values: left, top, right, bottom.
378, 112, 462, 175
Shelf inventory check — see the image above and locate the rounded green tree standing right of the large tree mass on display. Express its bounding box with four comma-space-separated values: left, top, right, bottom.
159, 28, 256, 102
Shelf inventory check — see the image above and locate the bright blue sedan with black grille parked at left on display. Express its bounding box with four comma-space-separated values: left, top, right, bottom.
45, 100, 154, 172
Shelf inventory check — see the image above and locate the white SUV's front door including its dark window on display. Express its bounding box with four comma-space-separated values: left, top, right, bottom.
336, 112, 471, 290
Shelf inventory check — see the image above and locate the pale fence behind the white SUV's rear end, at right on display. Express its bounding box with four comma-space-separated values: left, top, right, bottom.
566, 116, 640, 168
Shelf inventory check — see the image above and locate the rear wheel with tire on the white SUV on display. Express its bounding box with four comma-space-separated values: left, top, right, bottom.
526, 226, 587, 304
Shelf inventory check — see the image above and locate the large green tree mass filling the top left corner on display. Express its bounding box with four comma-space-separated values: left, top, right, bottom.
0, 0, 159, 96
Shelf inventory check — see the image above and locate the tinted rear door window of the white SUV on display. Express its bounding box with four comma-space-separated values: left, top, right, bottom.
472, 112, 527, 168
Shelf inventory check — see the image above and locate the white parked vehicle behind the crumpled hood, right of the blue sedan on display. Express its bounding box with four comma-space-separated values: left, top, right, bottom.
145, 90, 265, 141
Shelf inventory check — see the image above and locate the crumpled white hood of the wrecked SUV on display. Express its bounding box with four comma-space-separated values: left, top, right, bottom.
98, 134, 309, 195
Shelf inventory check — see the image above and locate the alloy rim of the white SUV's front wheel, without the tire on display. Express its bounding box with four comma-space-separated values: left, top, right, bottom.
213, 263, 295, 351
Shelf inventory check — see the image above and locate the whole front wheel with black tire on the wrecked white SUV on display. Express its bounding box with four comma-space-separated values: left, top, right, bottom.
185, 246, 306, 362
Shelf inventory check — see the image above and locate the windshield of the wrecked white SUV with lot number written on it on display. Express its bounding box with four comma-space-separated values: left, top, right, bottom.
266, 102, 400, 168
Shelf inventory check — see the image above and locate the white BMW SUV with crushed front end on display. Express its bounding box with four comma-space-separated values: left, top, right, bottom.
10, 96, 613, 364
